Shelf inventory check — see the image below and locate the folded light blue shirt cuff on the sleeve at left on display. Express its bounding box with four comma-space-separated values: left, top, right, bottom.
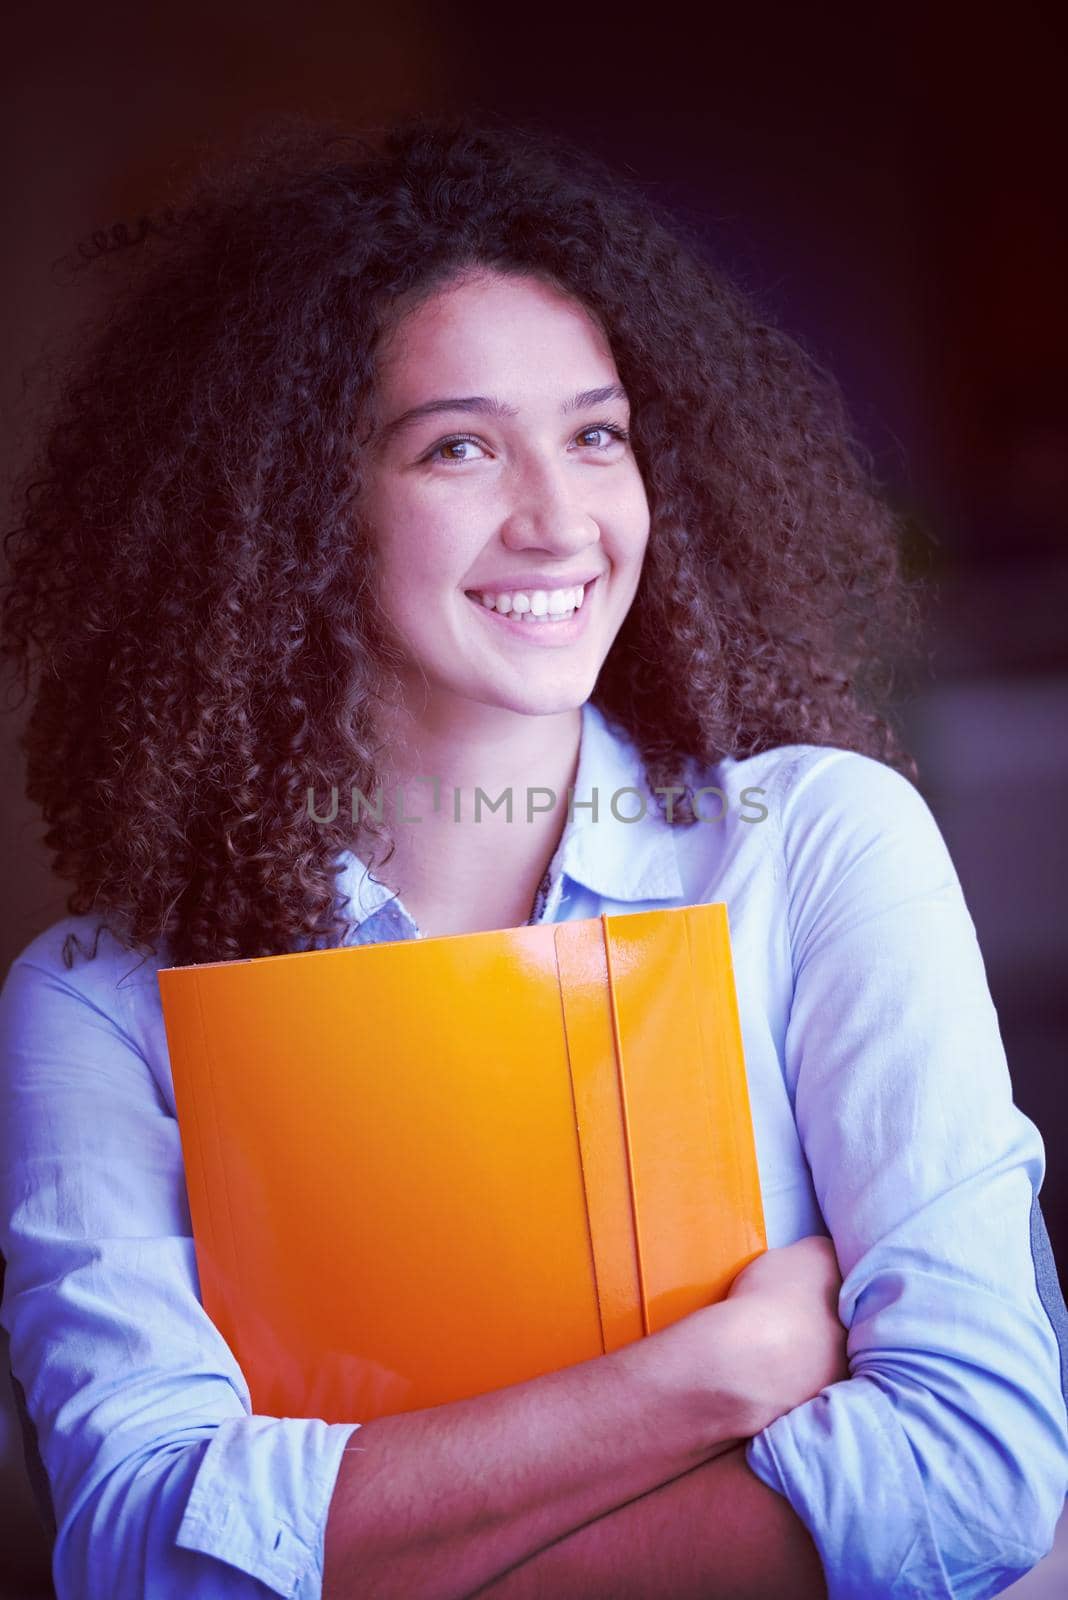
176, 1416, 360, 1600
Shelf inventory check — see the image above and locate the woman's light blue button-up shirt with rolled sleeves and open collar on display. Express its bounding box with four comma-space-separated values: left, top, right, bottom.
0, 704, 1068, 1600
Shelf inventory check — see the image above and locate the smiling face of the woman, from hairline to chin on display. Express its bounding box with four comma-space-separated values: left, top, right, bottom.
361, 272, 649, 715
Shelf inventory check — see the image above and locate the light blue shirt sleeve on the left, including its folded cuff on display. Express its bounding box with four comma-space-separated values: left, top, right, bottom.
0, 946, 360, 1600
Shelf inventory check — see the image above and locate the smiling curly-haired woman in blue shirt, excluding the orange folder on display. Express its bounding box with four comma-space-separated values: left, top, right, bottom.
0, 123, 1068, 1600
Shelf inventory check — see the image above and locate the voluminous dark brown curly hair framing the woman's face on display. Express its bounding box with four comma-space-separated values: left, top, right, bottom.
0, 117, 918, 965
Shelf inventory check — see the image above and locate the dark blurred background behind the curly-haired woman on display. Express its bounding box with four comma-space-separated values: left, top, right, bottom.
0, 0, 1068, 1597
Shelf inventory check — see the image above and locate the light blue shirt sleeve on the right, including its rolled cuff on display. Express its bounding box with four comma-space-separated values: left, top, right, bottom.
747, 750, 1068, 1600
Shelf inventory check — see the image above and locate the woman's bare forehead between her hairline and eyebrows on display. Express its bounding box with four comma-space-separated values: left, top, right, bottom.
377, 272, 619, 403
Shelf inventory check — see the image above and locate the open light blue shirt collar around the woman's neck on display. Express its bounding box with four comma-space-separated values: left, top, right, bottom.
339, 701, 684, 933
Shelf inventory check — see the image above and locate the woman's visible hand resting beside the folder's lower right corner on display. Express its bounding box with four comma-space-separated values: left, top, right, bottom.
722, 1235, 849, 1432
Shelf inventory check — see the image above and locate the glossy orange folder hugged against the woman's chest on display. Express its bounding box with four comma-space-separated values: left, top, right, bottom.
158, 904, 766, 1422
